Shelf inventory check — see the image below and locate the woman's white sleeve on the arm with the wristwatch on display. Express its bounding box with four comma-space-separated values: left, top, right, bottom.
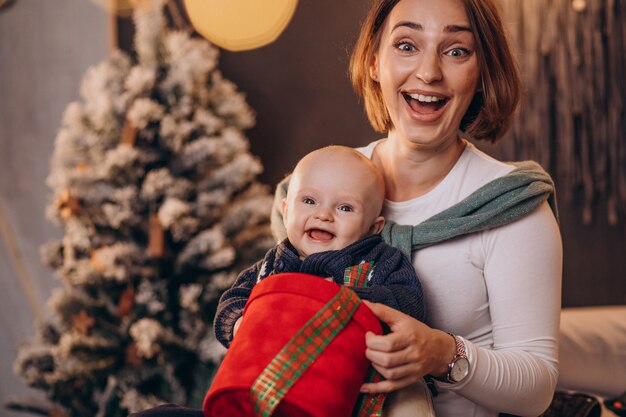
443, 203, 562, 416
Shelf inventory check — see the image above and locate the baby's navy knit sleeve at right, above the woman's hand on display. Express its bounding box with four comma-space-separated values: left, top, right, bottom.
354, 244, 426, 321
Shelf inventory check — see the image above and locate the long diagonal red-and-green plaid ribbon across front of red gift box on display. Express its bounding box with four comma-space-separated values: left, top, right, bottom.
250, 287, 361, 417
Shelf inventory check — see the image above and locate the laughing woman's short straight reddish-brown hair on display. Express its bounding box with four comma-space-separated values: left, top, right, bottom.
350, 0, 523, 142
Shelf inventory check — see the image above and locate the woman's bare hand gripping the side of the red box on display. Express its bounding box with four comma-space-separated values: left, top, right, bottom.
361, 301, 456, 393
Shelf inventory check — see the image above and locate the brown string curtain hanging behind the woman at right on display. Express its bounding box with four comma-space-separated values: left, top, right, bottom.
500, 0, 626, 225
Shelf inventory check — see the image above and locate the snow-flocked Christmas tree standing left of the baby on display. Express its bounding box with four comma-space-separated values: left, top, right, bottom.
5, 0, 273, 417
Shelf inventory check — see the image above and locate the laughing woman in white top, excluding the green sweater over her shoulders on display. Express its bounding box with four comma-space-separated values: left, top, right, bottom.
350, 0, 562, 417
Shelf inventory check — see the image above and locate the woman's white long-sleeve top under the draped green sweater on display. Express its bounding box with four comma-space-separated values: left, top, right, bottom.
359, 142, 562, 417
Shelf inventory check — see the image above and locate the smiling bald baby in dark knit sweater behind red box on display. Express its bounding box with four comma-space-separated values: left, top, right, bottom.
214, 146, 425, 347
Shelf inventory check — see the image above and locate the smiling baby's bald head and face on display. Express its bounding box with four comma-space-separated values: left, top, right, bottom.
283, 153, 384, 257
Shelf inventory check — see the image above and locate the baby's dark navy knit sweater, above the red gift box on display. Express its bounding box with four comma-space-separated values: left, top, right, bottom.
214, 235, 426, 347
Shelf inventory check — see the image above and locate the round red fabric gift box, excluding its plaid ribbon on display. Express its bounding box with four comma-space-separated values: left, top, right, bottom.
203, 273, 382, 417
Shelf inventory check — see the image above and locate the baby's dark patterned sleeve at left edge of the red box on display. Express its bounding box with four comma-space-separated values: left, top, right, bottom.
213, 261, 263, 348
